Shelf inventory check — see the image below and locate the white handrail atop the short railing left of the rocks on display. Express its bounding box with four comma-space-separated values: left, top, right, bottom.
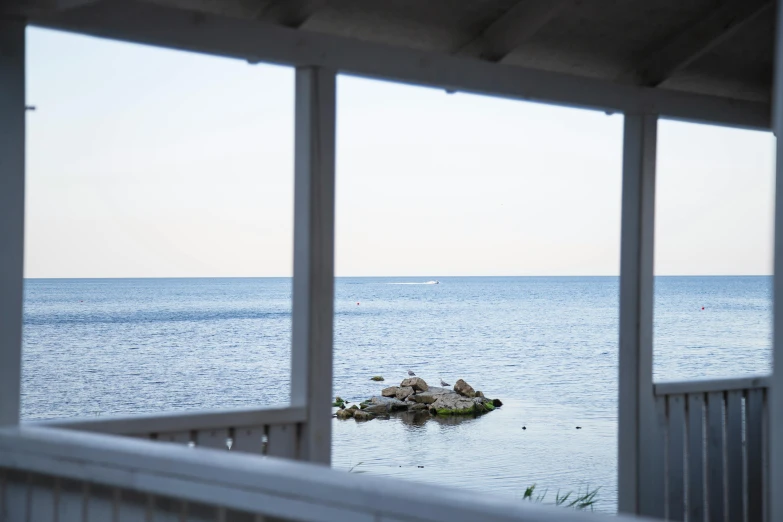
24, 406, 306, 435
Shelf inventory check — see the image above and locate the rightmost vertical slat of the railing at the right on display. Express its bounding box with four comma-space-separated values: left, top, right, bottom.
745, 390, 764, 522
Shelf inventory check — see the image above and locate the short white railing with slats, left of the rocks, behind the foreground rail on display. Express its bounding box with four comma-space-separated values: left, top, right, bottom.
25, 407, 305, 459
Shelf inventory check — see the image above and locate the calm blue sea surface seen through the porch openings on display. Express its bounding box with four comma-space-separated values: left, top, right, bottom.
22, 277, 771, 511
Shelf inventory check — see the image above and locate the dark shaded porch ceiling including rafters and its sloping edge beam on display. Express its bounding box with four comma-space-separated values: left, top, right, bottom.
7, 0, 775, 128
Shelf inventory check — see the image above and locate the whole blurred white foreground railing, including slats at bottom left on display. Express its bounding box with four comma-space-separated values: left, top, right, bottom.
0, 426, 640, 522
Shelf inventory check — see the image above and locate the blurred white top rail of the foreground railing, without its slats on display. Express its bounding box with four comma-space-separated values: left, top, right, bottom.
0, 426, 642, 522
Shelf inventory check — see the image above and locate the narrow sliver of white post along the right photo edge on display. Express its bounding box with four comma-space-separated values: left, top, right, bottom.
765, 1, 783, 520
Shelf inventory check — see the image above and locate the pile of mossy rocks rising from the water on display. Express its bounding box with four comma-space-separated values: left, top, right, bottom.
335, 377, 503, 421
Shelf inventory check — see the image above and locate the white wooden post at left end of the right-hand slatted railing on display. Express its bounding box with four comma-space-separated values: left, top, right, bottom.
618, 114, 664, 515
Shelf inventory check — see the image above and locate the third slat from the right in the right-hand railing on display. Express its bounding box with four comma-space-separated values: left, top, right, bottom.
707, 392, 726, 520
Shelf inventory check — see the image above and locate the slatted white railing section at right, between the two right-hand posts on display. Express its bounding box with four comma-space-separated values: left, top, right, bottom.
649, 377, 769, 522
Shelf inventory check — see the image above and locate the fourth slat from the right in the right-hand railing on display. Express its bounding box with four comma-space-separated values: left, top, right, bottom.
686, 393, 706, 521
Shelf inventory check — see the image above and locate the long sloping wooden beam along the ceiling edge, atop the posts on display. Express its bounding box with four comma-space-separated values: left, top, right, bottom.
30, 1, 770, 129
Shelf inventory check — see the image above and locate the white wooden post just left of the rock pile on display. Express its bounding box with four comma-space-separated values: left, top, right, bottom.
291, 67, 336, 465
